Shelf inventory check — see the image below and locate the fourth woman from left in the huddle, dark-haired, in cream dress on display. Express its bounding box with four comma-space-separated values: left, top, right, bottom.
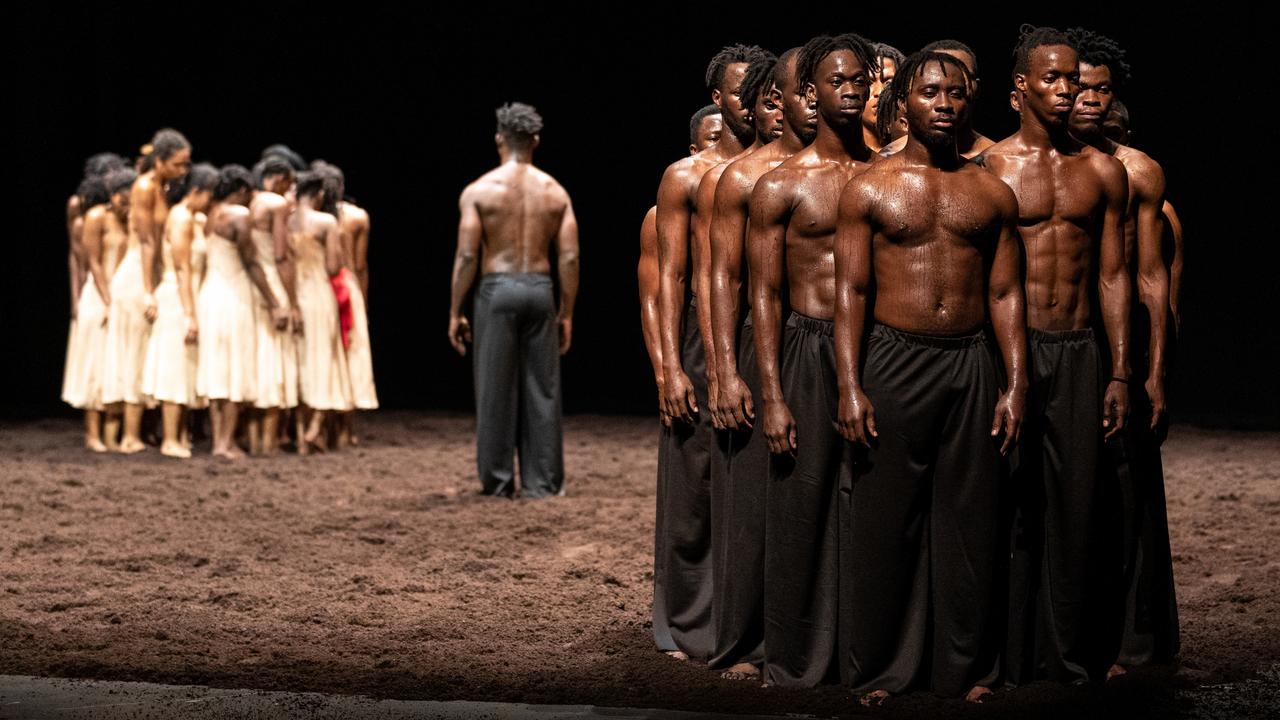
196, 168, 257, 459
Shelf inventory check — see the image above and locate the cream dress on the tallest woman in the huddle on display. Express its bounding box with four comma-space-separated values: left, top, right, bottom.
102, 231, 151, 404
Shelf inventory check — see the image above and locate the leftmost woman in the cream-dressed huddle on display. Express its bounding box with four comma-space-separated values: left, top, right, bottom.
63, 181, 129, 452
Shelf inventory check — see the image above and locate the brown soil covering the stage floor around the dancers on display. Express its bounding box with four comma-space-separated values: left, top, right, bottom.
0, 413, 1280, 719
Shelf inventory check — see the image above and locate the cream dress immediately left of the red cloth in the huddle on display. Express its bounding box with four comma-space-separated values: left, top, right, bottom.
291, 233, 351, 410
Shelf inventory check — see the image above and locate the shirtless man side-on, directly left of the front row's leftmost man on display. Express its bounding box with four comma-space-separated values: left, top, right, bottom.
703, 47, 818, 679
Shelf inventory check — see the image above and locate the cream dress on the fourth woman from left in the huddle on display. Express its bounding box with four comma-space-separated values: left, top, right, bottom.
196, 233, 257, 402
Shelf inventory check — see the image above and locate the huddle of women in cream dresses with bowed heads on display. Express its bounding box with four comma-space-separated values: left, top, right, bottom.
63, 129, 378, 457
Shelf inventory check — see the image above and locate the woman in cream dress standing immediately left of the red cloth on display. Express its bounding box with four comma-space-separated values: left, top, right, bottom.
289, 173, 351, 452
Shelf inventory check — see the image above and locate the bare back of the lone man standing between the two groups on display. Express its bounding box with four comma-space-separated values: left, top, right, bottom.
462, 163, 570, 273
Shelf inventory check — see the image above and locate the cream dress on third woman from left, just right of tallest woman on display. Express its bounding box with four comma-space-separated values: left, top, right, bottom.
142, 204, 198, 405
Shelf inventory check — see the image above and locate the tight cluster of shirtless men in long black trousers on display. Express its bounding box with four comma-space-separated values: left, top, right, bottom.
639, 27, 1180, 705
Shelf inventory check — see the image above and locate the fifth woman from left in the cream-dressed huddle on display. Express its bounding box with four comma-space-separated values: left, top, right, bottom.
246, 154, 296, 455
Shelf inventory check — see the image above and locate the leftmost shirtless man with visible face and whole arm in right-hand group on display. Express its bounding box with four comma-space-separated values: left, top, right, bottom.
653, 45, 764, 661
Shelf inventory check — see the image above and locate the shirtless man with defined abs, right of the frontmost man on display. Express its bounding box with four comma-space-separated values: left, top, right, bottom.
980, 26, 1130, 684
